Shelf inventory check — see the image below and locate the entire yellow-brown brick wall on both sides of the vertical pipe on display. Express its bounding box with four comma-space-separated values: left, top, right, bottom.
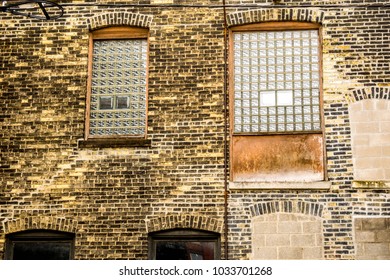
0, 0, 390, 259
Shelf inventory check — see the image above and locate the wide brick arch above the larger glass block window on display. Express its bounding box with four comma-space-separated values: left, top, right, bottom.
227, 8, 325, 26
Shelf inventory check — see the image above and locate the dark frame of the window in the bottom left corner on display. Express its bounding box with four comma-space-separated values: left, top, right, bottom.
4, 229, 75, 260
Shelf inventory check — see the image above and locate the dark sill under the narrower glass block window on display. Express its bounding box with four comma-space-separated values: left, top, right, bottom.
77, 138, 152, 149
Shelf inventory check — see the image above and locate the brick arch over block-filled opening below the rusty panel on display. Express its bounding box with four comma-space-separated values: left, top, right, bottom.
250, 200, 325, 218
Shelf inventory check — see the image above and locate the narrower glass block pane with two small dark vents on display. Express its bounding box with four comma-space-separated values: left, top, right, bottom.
89, 39, 147, 136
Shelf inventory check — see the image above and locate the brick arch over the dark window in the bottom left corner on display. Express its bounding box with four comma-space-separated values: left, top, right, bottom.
3, 216, 77, 234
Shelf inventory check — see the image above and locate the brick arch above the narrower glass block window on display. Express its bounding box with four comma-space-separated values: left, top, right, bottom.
87, 12, 152, 30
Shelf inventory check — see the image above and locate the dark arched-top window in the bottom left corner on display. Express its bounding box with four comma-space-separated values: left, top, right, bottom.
5, 230, 74, 260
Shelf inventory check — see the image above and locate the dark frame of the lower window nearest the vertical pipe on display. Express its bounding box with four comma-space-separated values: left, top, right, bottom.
148, 229, 221, 260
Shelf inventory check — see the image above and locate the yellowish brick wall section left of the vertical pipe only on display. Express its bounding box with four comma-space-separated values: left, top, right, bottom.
0, 1, 224, 259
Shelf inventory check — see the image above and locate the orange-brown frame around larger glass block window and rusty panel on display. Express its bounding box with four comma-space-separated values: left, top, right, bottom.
229, 21, 327, 182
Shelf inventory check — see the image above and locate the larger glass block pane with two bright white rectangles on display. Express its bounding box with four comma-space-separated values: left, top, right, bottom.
233, 30, 321, 133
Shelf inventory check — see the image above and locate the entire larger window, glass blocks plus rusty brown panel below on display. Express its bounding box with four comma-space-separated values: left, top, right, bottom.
230, 22, 325, 182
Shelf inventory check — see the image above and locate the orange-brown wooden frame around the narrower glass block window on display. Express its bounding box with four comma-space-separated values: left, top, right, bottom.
82, 26, 149, 140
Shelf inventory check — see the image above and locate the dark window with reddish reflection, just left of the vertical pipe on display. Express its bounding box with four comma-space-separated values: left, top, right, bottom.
149, 229, 220, 260
